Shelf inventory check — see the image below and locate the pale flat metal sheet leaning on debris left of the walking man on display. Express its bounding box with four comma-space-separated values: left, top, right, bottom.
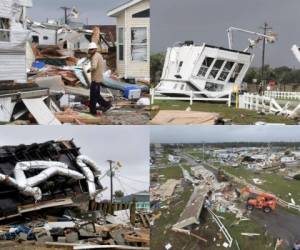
22, 97, 61, 125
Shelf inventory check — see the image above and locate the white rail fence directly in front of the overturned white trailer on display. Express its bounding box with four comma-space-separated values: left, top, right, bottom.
150, 89, 231, 107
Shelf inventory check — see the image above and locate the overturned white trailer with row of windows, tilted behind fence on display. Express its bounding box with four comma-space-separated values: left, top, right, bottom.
154, 42, 254, 100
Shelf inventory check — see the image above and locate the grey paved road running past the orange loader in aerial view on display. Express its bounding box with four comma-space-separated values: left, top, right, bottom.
182, 154, 300, 245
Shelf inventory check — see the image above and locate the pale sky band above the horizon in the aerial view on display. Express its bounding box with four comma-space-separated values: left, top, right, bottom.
151, 125, 300, 143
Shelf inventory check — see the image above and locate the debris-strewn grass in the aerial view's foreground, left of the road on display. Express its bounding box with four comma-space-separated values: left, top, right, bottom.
151, 165, 285, 250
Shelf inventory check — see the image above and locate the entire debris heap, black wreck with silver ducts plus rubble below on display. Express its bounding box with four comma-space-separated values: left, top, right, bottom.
0, 141, 153, 249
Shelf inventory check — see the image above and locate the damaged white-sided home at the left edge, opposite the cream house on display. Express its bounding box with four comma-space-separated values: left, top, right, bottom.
0, 0, 32, 82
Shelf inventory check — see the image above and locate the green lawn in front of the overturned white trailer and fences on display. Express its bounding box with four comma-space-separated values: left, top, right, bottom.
151, 100, 296, 125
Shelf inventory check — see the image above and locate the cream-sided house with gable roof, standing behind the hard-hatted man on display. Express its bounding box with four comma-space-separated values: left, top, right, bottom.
108, 0, 150, 80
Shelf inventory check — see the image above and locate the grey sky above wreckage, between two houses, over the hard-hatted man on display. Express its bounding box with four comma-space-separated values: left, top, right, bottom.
28, 0, 123, 25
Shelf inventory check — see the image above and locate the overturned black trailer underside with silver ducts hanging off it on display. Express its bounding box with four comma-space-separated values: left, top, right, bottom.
0, 141, 103, 220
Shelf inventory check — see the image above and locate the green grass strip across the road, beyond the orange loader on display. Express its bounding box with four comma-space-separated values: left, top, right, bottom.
224, 167, 300, 204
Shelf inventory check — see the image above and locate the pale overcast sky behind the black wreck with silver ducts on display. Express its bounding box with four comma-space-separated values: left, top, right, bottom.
0, 126, 149, 198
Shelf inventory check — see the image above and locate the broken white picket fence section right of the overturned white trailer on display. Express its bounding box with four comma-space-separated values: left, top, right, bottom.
239, 93, 285, 113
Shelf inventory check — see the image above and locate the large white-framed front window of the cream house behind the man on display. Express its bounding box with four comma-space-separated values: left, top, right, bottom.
131, 28, 148, 62
